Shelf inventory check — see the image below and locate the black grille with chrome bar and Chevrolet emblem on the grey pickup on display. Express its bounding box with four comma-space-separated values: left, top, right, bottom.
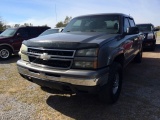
27, 48, 75, 69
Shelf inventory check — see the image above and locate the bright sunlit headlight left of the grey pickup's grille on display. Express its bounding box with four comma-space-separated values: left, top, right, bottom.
18, 44, 29, 61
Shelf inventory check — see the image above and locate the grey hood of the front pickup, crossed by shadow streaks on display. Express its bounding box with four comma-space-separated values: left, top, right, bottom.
23, 32, 118, 49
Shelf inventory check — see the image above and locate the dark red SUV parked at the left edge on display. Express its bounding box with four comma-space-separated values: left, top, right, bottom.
0, 26, 50, 60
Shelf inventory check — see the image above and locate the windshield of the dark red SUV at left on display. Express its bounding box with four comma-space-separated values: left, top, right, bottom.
0, 29, 17, 37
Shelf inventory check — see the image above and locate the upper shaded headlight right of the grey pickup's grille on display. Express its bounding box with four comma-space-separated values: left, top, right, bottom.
76, 48, 98, 57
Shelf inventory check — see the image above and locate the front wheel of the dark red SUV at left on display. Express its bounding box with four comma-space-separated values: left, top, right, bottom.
0, 46, 12, 60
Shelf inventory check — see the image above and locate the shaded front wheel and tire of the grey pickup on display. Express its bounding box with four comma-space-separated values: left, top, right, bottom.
99, 62, 123, 104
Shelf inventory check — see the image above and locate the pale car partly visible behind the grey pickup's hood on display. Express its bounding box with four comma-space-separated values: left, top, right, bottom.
39, 28, 64, 36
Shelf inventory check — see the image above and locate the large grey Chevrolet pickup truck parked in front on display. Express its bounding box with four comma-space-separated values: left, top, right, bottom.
17, 13, 143, 104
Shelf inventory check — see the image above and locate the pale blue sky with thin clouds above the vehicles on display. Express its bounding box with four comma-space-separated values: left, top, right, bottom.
0, 0, 160, 28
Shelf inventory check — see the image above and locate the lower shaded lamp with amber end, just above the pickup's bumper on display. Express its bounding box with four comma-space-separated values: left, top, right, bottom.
73, 61, 97, 69
